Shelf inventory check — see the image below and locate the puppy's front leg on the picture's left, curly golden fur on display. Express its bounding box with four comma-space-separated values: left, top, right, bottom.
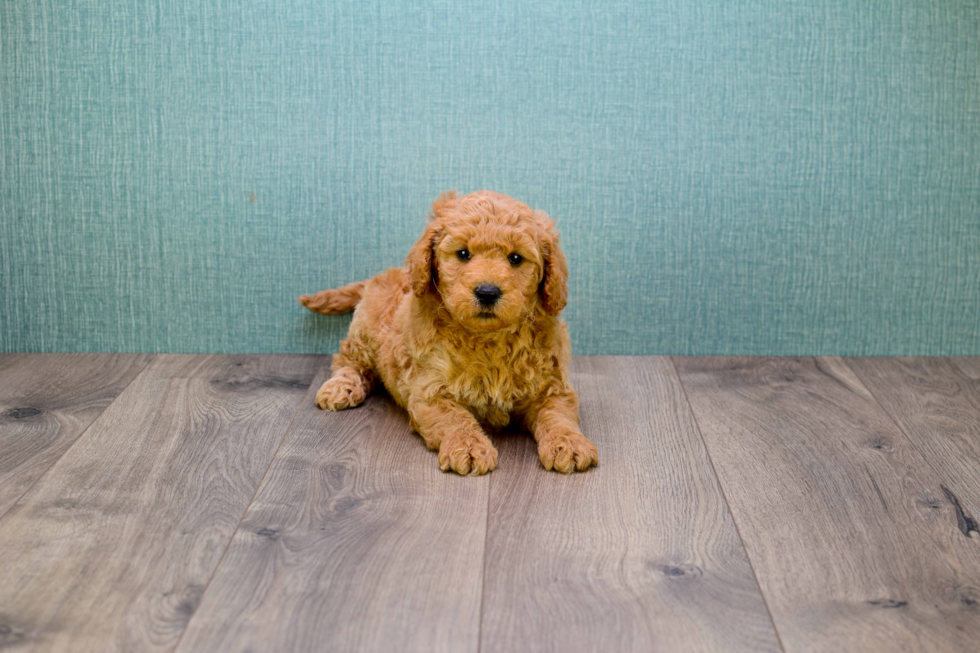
408, 399, 497, 476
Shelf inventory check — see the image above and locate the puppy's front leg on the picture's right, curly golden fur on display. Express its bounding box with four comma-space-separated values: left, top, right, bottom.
525, 392, 599, 474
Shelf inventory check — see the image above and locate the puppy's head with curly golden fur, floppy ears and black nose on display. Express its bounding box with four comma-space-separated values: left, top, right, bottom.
406, 191, 568, 331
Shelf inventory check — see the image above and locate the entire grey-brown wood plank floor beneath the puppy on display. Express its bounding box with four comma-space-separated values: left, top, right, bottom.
0, 354, 980, 653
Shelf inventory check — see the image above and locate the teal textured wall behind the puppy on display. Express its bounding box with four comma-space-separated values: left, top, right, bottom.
0, 0, 980, 355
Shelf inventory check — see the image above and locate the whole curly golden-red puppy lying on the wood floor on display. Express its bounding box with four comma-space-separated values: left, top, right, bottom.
299, 191, 599, 474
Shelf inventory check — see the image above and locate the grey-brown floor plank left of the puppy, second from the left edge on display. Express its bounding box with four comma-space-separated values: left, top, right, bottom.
0, 355, 320, 653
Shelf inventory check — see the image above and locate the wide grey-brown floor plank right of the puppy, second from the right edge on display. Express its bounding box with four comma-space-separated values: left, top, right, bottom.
675, 358, 980, 652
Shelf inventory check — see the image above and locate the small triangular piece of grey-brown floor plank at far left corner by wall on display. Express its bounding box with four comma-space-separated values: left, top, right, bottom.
0, 354, 152, 519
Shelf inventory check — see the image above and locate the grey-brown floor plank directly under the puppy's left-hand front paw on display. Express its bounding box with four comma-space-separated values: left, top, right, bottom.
178, 365, 489, 653
